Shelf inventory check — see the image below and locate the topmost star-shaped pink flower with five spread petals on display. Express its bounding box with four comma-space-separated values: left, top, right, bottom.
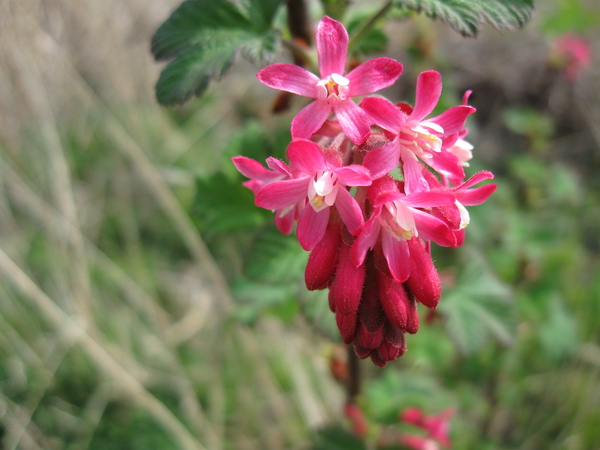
257, 16, 402, 144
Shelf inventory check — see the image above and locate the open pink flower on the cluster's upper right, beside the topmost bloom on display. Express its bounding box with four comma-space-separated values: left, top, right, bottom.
361, 70, 475, 194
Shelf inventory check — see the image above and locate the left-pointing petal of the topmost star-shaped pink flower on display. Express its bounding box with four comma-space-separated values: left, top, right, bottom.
256, 64, 319, 98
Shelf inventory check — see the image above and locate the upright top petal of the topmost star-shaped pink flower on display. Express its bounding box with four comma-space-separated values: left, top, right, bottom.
317, 16, 348, 78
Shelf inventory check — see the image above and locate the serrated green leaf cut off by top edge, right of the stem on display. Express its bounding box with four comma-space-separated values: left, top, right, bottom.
394, 0, 533, 36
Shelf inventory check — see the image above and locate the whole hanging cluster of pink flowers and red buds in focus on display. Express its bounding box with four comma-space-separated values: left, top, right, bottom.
233, 17, 496, 367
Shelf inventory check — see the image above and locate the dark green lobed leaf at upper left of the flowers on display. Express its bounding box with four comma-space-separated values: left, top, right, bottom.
152, 0, 282, 105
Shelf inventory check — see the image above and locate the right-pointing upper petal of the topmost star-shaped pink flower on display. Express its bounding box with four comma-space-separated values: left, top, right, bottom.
346, 58, 402, 97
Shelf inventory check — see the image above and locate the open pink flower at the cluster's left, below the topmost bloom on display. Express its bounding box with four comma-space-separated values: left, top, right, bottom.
250, 139, 371, 250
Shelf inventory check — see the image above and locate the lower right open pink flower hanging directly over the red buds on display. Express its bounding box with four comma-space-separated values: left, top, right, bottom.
352, 176, 456, 283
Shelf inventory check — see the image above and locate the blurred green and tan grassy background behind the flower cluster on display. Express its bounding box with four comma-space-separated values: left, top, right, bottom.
0, 0, 600, 450
